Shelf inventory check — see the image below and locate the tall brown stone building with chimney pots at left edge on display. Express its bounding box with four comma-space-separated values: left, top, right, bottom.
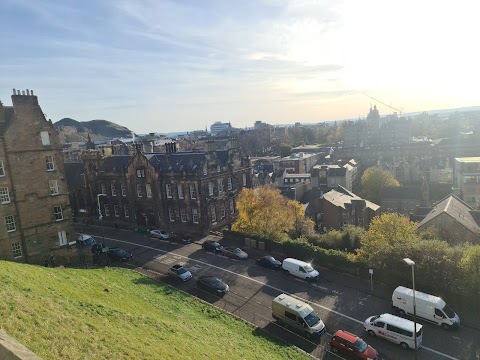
0, 89, 77, 264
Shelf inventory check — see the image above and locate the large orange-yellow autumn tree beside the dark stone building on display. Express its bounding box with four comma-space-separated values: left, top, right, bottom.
232, 186, 313, 241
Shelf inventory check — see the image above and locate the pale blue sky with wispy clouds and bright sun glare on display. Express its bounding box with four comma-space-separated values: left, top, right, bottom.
0, 0, 480, 134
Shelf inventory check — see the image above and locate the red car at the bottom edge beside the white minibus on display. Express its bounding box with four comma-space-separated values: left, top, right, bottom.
330, 330, 378, 360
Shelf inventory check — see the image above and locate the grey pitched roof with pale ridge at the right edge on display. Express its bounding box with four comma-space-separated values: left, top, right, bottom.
418, 195, 480, 234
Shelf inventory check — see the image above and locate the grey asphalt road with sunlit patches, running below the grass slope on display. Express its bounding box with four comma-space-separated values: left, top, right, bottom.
80, 227, 480, 360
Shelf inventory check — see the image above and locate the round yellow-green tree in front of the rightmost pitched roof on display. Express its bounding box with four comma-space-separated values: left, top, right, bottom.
357, 213, 419, 269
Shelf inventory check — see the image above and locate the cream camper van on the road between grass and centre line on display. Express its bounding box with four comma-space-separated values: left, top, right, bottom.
272, 294, 325, 337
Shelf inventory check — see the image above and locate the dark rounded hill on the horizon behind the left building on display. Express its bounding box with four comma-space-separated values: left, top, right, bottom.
53, 118, 132, 143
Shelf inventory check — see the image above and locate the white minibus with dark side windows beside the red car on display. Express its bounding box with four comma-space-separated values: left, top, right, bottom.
363, 314, 423, 349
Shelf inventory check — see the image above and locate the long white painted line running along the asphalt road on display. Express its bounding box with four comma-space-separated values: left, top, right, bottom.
105, 237, 460, 360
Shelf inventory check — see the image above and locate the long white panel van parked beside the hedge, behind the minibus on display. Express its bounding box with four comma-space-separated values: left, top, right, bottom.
392, 286, 460, 330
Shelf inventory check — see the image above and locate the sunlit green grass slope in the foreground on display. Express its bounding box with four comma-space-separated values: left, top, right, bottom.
0, 261, 309, 360
